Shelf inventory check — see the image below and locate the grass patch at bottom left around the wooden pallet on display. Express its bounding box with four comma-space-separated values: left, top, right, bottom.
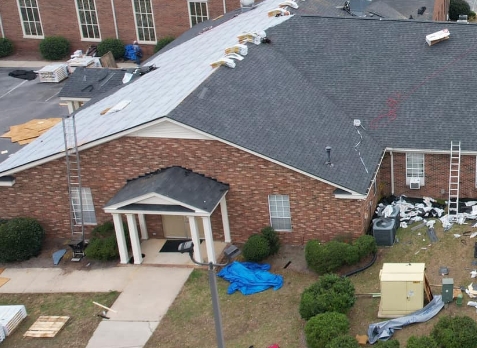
0, 291, 119, 348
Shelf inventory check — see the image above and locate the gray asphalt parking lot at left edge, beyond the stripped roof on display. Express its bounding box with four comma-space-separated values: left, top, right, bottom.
0, 67, 68, 162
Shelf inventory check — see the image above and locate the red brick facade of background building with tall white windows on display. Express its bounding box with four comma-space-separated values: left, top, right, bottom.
0, 0, 240, 56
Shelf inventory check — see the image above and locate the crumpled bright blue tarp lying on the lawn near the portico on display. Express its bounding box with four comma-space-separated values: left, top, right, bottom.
217, 261, 283, 295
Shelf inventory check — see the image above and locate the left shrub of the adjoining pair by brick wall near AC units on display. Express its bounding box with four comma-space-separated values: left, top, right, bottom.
305, 240, 349, 274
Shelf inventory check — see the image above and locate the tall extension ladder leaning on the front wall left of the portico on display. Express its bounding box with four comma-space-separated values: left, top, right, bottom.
62, 115, 85, 261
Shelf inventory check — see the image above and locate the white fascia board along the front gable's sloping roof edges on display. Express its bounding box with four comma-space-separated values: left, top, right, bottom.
0, 117, 362, 196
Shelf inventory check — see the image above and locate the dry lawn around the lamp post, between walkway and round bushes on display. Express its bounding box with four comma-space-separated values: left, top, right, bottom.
145, 269, 317, 348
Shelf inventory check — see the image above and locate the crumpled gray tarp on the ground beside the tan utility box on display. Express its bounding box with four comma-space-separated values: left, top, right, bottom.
368, 295, 444, 344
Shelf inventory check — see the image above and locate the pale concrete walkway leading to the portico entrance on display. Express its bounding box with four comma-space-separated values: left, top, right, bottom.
0, 265, 192, 348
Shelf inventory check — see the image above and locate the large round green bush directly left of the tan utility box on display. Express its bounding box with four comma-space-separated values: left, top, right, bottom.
299, 274, 356, 320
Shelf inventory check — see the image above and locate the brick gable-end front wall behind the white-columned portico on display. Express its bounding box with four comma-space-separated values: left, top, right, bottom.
0, 137, 377, 245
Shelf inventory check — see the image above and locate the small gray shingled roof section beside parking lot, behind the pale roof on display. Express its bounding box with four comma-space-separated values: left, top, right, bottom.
58, 67, 127, 98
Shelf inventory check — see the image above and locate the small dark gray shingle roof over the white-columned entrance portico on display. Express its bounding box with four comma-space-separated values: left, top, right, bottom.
105, 167, 229, 213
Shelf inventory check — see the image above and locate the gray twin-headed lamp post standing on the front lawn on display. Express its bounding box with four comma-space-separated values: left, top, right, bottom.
179, 241, 240, 348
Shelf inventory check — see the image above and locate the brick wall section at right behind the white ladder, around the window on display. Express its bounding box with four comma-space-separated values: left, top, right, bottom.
379, 153, 477, 199
